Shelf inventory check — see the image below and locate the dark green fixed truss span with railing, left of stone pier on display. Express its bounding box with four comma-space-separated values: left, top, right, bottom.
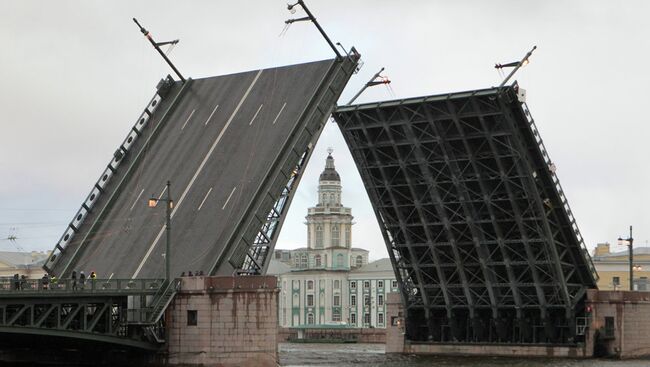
0, 279, 179, 350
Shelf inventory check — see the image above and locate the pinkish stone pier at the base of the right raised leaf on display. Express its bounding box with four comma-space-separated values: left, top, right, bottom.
386, 289, 650, 359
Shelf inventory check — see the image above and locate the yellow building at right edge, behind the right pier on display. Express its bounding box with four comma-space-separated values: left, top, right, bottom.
593, 243, 650, 291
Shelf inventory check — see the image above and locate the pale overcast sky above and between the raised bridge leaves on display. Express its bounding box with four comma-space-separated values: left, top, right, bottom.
0, 0, 650, 259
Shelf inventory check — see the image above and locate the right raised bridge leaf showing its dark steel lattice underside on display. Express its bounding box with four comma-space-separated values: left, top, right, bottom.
334, 85, 596, 344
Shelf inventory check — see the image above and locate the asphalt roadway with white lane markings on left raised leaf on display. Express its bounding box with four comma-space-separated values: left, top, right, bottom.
54, 60, 334, 278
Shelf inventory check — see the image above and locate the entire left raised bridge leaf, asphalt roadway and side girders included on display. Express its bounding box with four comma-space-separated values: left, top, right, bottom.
45, 51, 359, 279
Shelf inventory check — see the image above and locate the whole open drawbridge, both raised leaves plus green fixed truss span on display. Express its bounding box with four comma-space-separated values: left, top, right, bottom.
10, 33, 597, 350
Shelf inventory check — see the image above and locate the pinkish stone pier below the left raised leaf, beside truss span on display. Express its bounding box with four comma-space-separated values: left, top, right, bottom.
165, 276, 278, 367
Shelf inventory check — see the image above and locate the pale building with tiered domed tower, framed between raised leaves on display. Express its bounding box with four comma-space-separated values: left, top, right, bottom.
268, 151, 398, 327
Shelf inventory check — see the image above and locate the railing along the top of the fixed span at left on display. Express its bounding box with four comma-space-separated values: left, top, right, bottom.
0, 278, 166, 295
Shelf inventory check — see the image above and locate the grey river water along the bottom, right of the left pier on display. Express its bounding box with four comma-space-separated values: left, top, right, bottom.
279, 343, 650, 367
